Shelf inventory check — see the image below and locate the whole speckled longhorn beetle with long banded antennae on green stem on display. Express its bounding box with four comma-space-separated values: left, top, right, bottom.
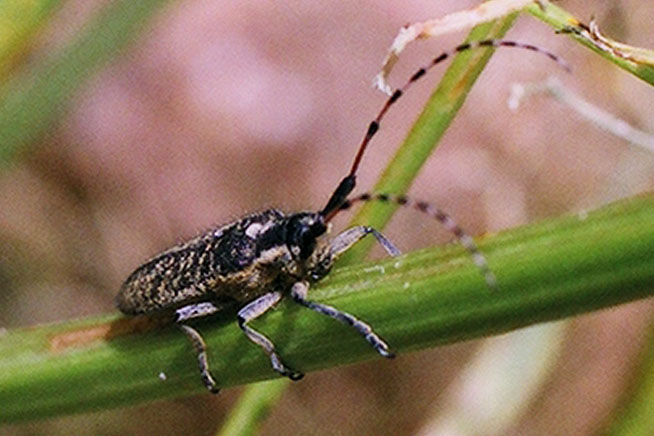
116, 40, 569, 393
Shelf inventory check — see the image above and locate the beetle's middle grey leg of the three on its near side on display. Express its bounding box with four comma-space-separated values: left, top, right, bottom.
238, 292, 304, 380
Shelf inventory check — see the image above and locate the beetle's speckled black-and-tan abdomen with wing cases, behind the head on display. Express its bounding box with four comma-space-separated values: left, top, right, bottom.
116, 209, 287, 315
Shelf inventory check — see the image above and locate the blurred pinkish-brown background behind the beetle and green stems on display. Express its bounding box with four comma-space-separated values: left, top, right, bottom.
0, 0, 654, 435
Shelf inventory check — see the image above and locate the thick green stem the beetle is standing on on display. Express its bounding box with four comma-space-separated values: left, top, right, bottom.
0, 195, 654, 422
